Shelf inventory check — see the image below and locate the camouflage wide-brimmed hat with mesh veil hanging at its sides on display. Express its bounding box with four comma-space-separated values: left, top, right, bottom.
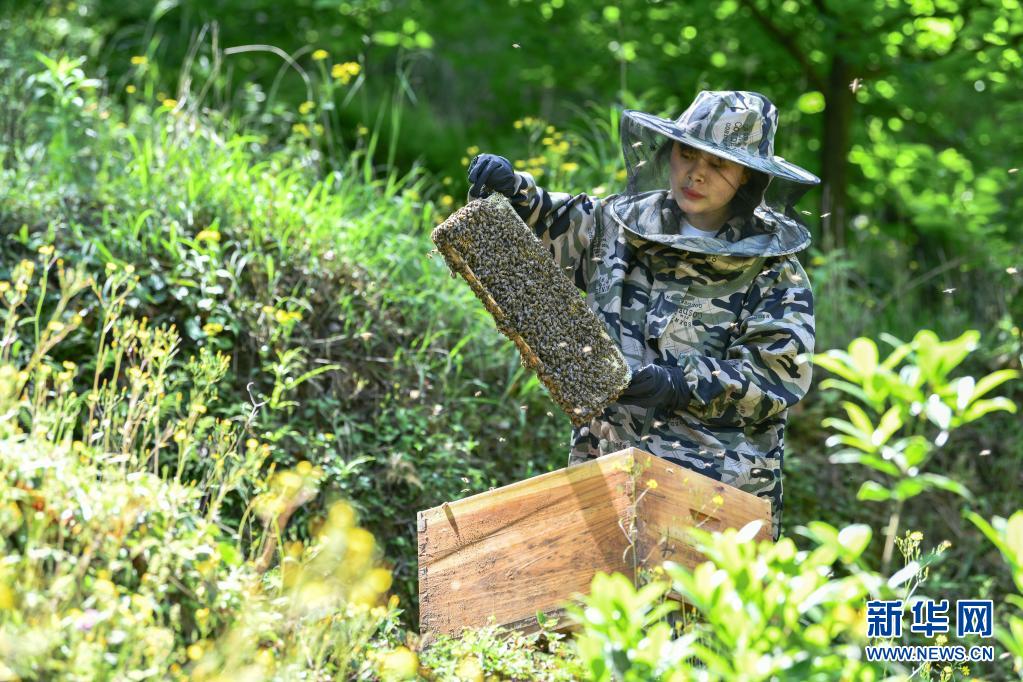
620, 91, 820, 231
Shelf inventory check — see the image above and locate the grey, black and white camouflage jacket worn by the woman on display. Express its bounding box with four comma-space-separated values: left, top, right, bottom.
486, 172, 814, 539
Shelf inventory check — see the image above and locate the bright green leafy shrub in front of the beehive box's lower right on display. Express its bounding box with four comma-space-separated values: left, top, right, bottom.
573, 521, 965, 680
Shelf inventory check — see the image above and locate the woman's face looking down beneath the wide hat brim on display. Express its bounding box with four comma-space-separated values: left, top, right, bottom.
671, 142, 749, 231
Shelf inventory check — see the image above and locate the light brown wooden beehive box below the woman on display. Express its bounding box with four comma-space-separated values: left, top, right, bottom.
418, 448, 771, 636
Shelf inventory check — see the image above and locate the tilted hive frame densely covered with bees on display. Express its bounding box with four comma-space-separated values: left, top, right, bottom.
431, 192, 631, 426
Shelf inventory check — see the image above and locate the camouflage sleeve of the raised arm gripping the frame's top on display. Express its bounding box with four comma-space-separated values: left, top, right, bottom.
493, 171, 601, 291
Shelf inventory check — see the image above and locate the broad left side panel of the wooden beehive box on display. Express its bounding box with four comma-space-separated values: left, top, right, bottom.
419, 458, 629, 633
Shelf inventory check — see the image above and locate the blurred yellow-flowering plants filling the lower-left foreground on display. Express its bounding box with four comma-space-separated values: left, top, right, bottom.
0, 259, 401, 680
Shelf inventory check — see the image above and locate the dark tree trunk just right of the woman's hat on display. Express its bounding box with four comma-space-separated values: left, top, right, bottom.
820, 51, 854, 251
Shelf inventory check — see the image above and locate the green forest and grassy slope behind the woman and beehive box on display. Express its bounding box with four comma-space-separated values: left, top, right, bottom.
0, 0, 1023, 678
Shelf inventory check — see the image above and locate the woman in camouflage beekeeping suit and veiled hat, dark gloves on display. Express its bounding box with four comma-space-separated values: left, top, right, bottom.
469, 91, 819, 540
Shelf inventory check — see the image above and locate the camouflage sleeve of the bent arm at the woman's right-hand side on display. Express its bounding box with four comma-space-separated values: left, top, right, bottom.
679, 255, 815, 426
